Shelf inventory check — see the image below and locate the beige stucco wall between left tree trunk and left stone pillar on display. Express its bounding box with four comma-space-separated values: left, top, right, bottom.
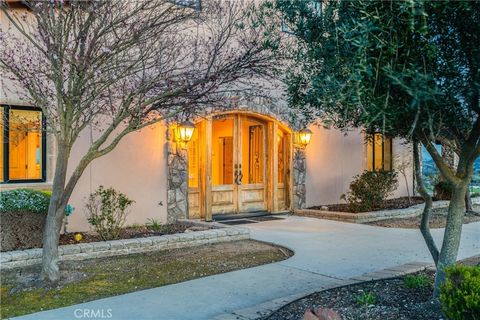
65, 124, 167, 231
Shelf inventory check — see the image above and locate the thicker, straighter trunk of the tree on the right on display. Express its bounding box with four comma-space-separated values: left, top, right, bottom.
434, 179, 470, 297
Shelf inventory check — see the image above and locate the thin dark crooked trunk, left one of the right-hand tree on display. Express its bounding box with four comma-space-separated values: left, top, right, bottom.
413, 142, 439, 265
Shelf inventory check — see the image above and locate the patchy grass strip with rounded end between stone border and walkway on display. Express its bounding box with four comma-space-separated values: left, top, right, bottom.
1, 240, 293, 318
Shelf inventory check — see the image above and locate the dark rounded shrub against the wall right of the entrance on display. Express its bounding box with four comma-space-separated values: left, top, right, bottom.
342, 171, 398, 212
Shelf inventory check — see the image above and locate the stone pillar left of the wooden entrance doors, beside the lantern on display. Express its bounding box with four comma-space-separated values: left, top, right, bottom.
167, 130, 188, 223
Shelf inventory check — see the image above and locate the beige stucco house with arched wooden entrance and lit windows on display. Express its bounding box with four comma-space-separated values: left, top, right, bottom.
0, 0, 413, 231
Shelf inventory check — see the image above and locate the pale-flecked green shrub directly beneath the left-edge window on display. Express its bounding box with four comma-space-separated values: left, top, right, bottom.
0, 189, 50, 214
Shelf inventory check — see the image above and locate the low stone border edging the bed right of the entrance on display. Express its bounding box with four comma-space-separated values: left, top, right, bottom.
295, 197, 480, 223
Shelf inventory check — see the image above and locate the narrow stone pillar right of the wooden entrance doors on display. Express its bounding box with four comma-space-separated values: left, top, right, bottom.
293, 147, 307, 210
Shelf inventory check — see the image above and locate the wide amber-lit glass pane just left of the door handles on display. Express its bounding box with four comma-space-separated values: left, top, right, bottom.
212, 117, 234, 186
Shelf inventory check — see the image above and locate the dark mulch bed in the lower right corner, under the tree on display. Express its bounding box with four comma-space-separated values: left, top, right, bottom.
267, 256, 480, 320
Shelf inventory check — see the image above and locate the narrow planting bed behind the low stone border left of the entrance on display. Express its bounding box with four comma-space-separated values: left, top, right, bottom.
60, 224, 201, 245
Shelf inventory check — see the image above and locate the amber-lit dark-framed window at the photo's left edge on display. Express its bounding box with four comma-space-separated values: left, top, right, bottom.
0, 106, 46, 183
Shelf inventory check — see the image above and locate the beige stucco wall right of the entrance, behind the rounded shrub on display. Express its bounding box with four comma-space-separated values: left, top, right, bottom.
305, 126, 413, 207
